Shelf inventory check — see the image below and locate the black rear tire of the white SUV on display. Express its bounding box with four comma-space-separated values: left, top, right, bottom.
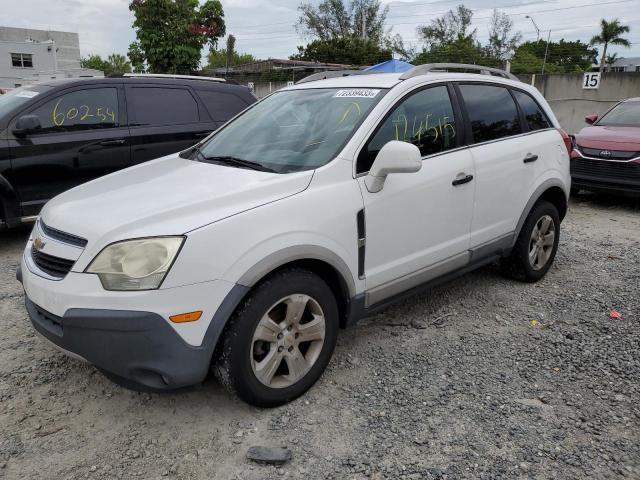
501, 200, 560, 282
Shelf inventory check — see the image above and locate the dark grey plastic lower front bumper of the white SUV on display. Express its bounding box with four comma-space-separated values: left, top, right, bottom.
25, 297, 214, 390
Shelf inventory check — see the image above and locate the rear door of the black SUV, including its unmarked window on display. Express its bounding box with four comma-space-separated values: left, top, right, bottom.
126, 84, 216, 164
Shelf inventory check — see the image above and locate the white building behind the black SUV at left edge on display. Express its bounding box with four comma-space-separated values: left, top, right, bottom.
0, 27, 104, 89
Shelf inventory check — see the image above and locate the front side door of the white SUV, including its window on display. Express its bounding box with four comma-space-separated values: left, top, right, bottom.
357, 84, 475, 306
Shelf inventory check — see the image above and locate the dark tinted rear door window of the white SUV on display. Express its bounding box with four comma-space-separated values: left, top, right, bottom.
460, 84, 522, 143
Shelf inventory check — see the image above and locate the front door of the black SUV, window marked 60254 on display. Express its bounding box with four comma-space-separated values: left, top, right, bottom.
8, 83, 131, 216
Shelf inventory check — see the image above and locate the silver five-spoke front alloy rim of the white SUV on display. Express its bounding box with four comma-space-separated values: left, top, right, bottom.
250, 294, 326, 388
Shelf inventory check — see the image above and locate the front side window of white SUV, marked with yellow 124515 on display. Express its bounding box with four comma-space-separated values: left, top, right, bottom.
357, 85, 457, 173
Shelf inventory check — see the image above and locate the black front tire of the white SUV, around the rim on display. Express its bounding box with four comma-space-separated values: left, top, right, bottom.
213, 268, 339, 407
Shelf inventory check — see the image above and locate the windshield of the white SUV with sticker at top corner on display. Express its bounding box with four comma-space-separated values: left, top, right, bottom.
199, 88, 386, 173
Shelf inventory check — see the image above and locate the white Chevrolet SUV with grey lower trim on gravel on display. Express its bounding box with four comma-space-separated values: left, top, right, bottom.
18, 65, 571, 406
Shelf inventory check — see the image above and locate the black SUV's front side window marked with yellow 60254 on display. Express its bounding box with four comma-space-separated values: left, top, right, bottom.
30, 88, 118, 133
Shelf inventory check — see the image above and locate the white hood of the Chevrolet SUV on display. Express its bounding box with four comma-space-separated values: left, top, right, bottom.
41, 154, 313, 245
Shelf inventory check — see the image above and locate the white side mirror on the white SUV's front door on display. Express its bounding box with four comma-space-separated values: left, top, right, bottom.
364, 140, 422, 193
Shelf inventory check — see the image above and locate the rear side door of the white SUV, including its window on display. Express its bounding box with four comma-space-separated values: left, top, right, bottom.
458, 83, 544, 247
